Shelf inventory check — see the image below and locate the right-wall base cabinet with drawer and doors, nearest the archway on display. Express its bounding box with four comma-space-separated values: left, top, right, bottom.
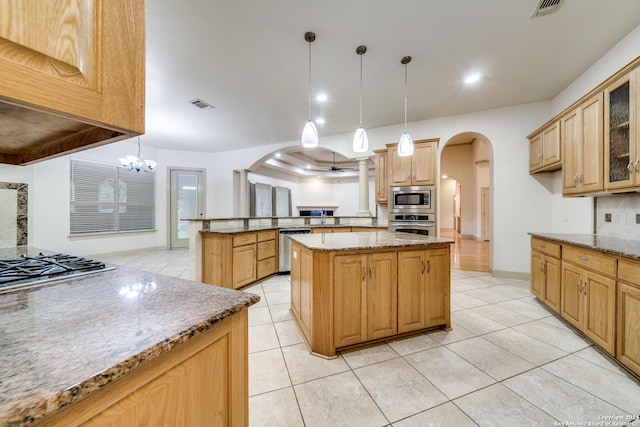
531, 237, 562, 313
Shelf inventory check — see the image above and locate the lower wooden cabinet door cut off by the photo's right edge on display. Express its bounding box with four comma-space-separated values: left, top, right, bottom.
616, 282, 640, 375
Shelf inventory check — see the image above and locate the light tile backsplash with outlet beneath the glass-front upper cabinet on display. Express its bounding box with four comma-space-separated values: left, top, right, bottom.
594, 193, 640, 240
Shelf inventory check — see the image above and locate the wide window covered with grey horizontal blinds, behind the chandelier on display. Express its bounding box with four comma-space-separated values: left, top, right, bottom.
69, 160, 155, 235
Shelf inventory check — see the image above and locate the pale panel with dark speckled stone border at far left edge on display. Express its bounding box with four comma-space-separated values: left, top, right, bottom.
0, 182, 29, 247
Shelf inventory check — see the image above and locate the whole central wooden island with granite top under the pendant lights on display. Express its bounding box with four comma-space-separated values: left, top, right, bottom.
291, 231, 453, 358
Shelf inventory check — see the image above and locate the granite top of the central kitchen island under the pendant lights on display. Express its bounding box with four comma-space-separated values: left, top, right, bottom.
289, 231, 454, 251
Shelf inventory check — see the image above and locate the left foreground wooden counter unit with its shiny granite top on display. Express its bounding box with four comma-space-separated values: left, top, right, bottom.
0, 247, 259, 427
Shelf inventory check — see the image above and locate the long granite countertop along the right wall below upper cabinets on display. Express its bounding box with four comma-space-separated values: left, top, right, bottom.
529, 233, 640, 260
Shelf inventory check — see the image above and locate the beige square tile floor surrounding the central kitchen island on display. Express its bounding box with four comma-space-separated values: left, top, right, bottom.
103, 250, 640, 427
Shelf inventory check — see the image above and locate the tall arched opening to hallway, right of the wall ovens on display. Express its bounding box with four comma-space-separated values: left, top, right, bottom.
438, 132, 493, 272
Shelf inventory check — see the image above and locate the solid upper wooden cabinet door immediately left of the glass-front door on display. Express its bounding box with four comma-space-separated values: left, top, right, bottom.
579, 93, 604, 193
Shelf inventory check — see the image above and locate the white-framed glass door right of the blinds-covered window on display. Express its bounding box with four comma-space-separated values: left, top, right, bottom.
169, 169, 205, 248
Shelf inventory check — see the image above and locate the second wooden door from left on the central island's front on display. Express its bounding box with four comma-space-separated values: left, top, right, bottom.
365, 252, 398, 340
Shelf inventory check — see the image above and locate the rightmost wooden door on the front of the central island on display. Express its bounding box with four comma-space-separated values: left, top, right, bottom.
424, 249, 451, 328
